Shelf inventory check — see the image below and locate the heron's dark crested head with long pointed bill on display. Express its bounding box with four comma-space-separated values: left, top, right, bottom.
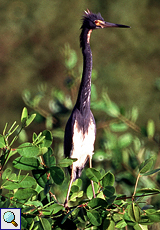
81, 10, 130, 30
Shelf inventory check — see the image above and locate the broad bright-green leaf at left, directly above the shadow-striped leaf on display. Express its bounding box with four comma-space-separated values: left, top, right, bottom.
17, 142, 40, 158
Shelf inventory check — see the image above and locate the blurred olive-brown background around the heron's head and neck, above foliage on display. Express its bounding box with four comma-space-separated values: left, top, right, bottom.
0, 0, 160, 136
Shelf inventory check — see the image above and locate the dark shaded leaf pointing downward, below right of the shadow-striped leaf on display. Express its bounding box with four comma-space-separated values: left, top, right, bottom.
32, 169, 48, 188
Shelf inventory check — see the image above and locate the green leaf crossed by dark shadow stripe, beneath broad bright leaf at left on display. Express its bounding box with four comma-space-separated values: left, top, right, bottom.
13, 157, 39, 170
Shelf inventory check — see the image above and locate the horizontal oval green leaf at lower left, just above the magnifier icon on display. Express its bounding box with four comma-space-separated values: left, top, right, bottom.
14, 188, 37, 200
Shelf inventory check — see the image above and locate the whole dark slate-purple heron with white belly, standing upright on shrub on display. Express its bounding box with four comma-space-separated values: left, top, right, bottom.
64, 9, 129, 207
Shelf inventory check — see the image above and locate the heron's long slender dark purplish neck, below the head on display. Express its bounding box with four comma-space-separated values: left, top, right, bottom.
76, 29, 92, 114
